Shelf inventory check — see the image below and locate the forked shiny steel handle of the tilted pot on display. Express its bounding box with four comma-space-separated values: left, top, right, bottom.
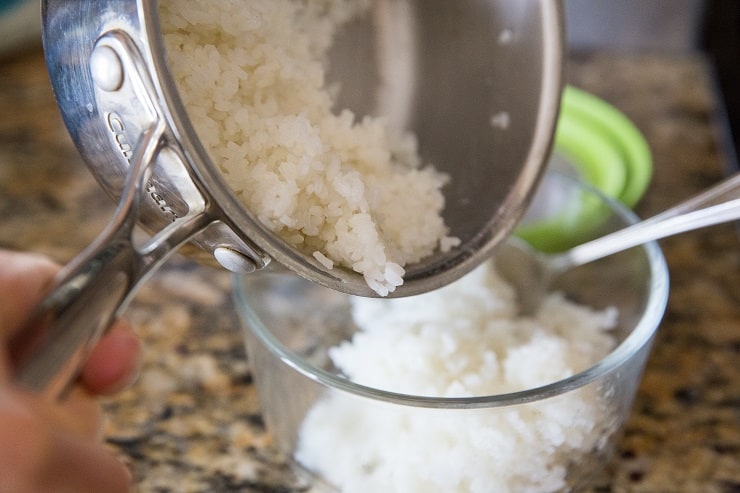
8, 124, 216, 399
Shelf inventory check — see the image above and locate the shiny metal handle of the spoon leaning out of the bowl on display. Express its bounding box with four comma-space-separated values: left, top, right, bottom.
552, 173, 740, 271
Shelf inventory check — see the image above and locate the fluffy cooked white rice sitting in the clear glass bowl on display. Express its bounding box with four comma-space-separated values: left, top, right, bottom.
296, 264, 616, 493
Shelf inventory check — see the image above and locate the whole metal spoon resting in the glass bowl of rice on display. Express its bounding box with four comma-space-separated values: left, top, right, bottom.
494, 173, 740, 314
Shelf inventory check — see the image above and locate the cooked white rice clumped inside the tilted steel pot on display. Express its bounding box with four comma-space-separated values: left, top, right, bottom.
160, 0, 457, 295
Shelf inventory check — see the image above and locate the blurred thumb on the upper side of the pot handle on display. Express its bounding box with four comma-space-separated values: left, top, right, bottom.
0, 249, 59, 338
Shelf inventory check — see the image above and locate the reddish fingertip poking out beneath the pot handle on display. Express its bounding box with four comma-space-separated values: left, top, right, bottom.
80, 320, 143, 395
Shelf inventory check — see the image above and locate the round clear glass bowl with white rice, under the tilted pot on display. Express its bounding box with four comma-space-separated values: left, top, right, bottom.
234, 172, 669, 493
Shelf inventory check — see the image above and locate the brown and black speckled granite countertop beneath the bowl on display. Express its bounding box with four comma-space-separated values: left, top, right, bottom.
0, 47, 740, 493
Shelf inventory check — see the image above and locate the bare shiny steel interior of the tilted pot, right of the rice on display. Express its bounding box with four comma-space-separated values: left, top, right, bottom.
312, 0, 562, 286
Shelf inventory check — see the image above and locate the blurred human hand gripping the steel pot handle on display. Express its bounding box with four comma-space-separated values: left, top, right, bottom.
0, 250, 141, 493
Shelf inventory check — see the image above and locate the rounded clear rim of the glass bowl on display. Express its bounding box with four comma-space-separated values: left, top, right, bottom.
232, 171, 669, 409
